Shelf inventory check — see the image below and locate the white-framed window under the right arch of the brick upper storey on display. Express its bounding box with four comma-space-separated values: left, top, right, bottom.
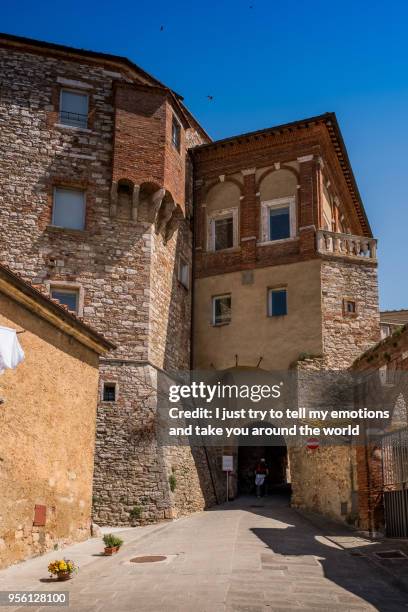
262, 197, 296, 242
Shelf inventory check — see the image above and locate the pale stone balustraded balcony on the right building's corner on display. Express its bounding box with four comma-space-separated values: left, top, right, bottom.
316, 230, 377, 261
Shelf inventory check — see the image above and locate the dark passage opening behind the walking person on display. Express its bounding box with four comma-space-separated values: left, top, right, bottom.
237, 446, 290, 495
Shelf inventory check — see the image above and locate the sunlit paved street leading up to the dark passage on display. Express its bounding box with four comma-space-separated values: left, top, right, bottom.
0, 497, 408, 612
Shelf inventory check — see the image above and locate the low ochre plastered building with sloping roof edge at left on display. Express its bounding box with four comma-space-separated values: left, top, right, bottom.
0, 266, 113, 568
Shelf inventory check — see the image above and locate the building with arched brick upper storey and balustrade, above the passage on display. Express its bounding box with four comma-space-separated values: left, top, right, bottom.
193, 113, 380, 518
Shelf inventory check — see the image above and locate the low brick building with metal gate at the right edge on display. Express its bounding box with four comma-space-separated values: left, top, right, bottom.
352, 326, 408, 538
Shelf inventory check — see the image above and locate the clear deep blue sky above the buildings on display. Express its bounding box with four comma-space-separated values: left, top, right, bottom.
0, 0, 408, 309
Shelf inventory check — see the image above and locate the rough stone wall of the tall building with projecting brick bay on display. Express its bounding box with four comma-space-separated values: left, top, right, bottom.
0, 45, 215, 525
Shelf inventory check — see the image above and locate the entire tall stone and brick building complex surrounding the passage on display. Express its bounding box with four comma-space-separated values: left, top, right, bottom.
0, 29, 379, 524
